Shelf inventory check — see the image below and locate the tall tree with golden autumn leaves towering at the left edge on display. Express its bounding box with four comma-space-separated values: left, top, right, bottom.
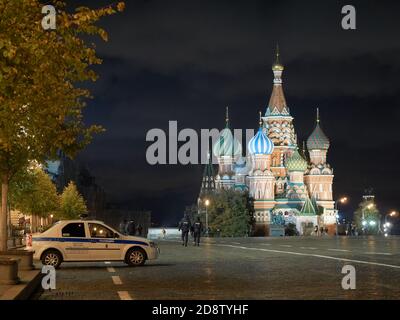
0, 0, 124, 250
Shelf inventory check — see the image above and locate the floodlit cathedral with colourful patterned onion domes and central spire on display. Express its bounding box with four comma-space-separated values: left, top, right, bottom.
199, 48, 336, 236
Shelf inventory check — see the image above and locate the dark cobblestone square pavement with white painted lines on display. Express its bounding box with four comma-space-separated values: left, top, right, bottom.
35, 237, 400, 300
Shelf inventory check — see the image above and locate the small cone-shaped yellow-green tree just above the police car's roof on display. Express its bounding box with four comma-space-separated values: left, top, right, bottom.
58, 181, 87, 219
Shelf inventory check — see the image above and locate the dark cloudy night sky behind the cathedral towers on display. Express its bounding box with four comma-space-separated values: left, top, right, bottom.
72, 0, 400, 224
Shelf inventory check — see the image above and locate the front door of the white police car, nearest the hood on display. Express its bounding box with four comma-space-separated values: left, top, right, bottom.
88, 222, 121, 261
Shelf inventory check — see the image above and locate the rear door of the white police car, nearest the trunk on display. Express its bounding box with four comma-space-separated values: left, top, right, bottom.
59, 222, 89, 261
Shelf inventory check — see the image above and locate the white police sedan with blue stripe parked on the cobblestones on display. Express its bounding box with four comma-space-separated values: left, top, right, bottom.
32, 220, 159, 268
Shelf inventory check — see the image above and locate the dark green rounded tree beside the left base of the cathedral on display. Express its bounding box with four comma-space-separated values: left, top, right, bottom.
207, 190, 253, 237
